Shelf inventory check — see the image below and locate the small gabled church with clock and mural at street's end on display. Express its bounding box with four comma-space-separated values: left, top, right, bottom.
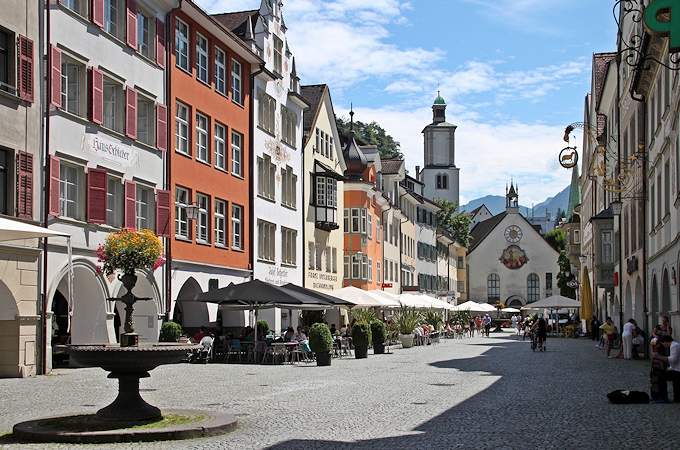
467, 184, 559, 307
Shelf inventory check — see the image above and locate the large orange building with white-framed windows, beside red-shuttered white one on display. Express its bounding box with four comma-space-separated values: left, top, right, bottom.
168, 1, 262, 328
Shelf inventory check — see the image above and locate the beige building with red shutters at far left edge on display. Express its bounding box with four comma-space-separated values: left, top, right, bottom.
0, 0, 43, 377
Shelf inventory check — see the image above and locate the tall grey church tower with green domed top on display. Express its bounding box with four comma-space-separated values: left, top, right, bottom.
418, 92, 460, 205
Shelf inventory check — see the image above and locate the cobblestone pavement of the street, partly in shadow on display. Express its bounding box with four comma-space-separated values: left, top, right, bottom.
0, 334, 680, 450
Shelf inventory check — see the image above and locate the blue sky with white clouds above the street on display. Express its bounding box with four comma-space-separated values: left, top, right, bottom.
197, 0, 615, 204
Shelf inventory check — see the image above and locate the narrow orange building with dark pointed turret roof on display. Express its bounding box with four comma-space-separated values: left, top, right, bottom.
343, 132, 389, 290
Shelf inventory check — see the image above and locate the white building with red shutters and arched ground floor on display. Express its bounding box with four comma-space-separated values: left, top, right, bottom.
43, 0, 177, 366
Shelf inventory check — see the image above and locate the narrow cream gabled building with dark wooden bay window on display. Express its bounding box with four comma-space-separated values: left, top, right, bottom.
300, 84, 347, 292
